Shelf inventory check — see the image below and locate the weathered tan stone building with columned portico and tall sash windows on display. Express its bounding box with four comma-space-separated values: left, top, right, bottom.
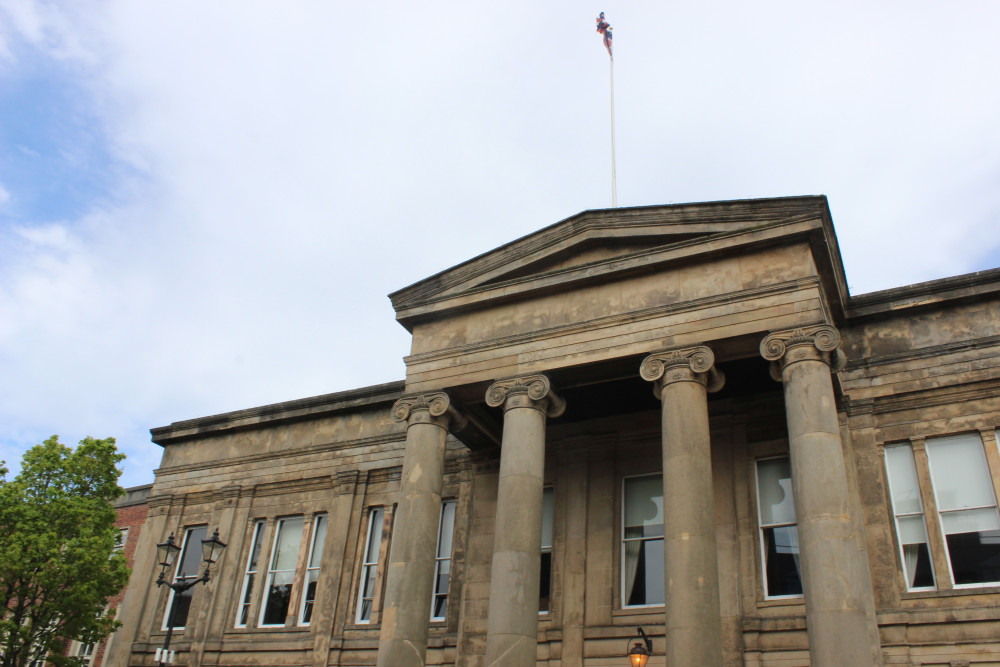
107, 197, 1000, 667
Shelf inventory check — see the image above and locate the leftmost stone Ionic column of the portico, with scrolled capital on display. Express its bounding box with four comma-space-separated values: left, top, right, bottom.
378, 392, 462, 667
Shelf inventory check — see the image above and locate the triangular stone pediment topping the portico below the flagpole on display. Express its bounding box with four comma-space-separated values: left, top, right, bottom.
389, 196, 829, 328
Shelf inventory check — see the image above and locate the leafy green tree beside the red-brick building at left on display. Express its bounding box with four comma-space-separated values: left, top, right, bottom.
0, 436, 129, 667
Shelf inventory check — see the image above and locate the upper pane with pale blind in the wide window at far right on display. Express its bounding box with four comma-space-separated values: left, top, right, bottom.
927, 434, 996, 512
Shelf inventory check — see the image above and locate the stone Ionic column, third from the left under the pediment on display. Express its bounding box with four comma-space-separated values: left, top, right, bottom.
639, 345, 725, 667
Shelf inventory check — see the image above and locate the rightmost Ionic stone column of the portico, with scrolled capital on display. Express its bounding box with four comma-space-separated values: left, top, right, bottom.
760, 324, 879, 667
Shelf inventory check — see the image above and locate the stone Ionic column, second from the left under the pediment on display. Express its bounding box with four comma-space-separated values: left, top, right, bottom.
486, 375, 566, 667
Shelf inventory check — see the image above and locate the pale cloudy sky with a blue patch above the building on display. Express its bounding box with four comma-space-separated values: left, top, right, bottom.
0, 0, 1000, 486
